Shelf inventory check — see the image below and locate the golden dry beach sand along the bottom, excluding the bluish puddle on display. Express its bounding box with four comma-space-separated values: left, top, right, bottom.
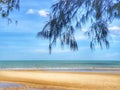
0, 70, 120, 90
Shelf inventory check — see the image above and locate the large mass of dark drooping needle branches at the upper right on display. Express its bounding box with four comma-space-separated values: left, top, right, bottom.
38, 0, 120, 51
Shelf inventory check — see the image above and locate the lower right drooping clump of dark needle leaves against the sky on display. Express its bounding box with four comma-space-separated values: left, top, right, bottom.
88, 20, 109, 49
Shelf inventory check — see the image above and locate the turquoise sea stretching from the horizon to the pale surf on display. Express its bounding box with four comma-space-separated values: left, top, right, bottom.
0, 60, 120, 72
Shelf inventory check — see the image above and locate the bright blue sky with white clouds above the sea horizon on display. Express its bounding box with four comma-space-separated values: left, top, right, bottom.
0, 0, 120, 60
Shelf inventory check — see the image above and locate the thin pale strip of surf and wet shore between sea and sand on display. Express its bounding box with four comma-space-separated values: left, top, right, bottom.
0, 68, 120, 74
